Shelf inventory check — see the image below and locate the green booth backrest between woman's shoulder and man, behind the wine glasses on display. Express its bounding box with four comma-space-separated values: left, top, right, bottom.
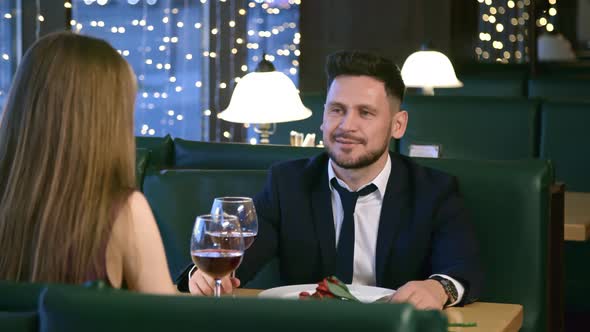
143, 169, 266, 278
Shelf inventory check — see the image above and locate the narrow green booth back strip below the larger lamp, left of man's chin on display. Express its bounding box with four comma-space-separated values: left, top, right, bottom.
174, 138, 323, 169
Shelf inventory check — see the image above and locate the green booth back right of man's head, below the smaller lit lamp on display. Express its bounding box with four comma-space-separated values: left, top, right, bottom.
400, 96, 538, 160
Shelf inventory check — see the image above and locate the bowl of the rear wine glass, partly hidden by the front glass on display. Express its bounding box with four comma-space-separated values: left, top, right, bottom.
211, 197, 258, 250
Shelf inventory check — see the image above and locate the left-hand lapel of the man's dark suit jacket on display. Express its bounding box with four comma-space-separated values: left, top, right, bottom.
306, 154, 336, 276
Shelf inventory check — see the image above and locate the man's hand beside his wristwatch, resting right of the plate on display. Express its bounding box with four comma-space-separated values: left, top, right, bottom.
391, 279, 448, 310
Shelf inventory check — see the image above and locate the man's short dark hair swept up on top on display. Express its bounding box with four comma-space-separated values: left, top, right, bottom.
326, 51, 406, 101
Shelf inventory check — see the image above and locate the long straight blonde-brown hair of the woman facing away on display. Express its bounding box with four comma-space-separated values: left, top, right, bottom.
0, 32, 136, 283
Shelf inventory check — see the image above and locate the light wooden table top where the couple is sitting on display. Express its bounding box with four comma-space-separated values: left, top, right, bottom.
234, 288, 523, 332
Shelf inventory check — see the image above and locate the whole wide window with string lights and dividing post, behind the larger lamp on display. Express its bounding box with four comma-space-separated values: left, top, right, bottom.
70, 0, 300, 141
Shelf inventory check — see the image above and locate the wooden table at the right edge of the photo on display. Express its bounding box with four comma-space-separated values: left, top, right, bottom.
563, 191, 590, 241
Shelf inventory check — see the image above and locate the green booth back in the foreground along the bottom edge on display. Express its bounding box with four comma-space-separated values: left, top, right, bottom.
39, 288, 447, 332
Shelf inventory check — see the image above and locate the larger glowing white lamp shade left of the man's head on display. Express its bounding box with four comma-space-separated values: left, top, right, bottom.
219, 71, 311, 123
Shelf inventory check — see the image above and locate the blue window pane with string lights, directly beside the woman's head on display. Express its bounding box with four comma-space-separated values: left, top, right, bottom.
71, 0, 209, 140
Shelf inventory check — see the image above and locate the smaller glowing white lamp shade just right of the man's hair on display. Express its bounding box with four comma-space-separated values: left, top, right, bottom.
402, 51, 463, 88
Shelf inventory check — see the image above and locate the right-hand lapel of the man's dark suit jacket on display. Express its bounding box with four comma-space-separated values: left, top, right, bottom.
375, 153, 410, 286
